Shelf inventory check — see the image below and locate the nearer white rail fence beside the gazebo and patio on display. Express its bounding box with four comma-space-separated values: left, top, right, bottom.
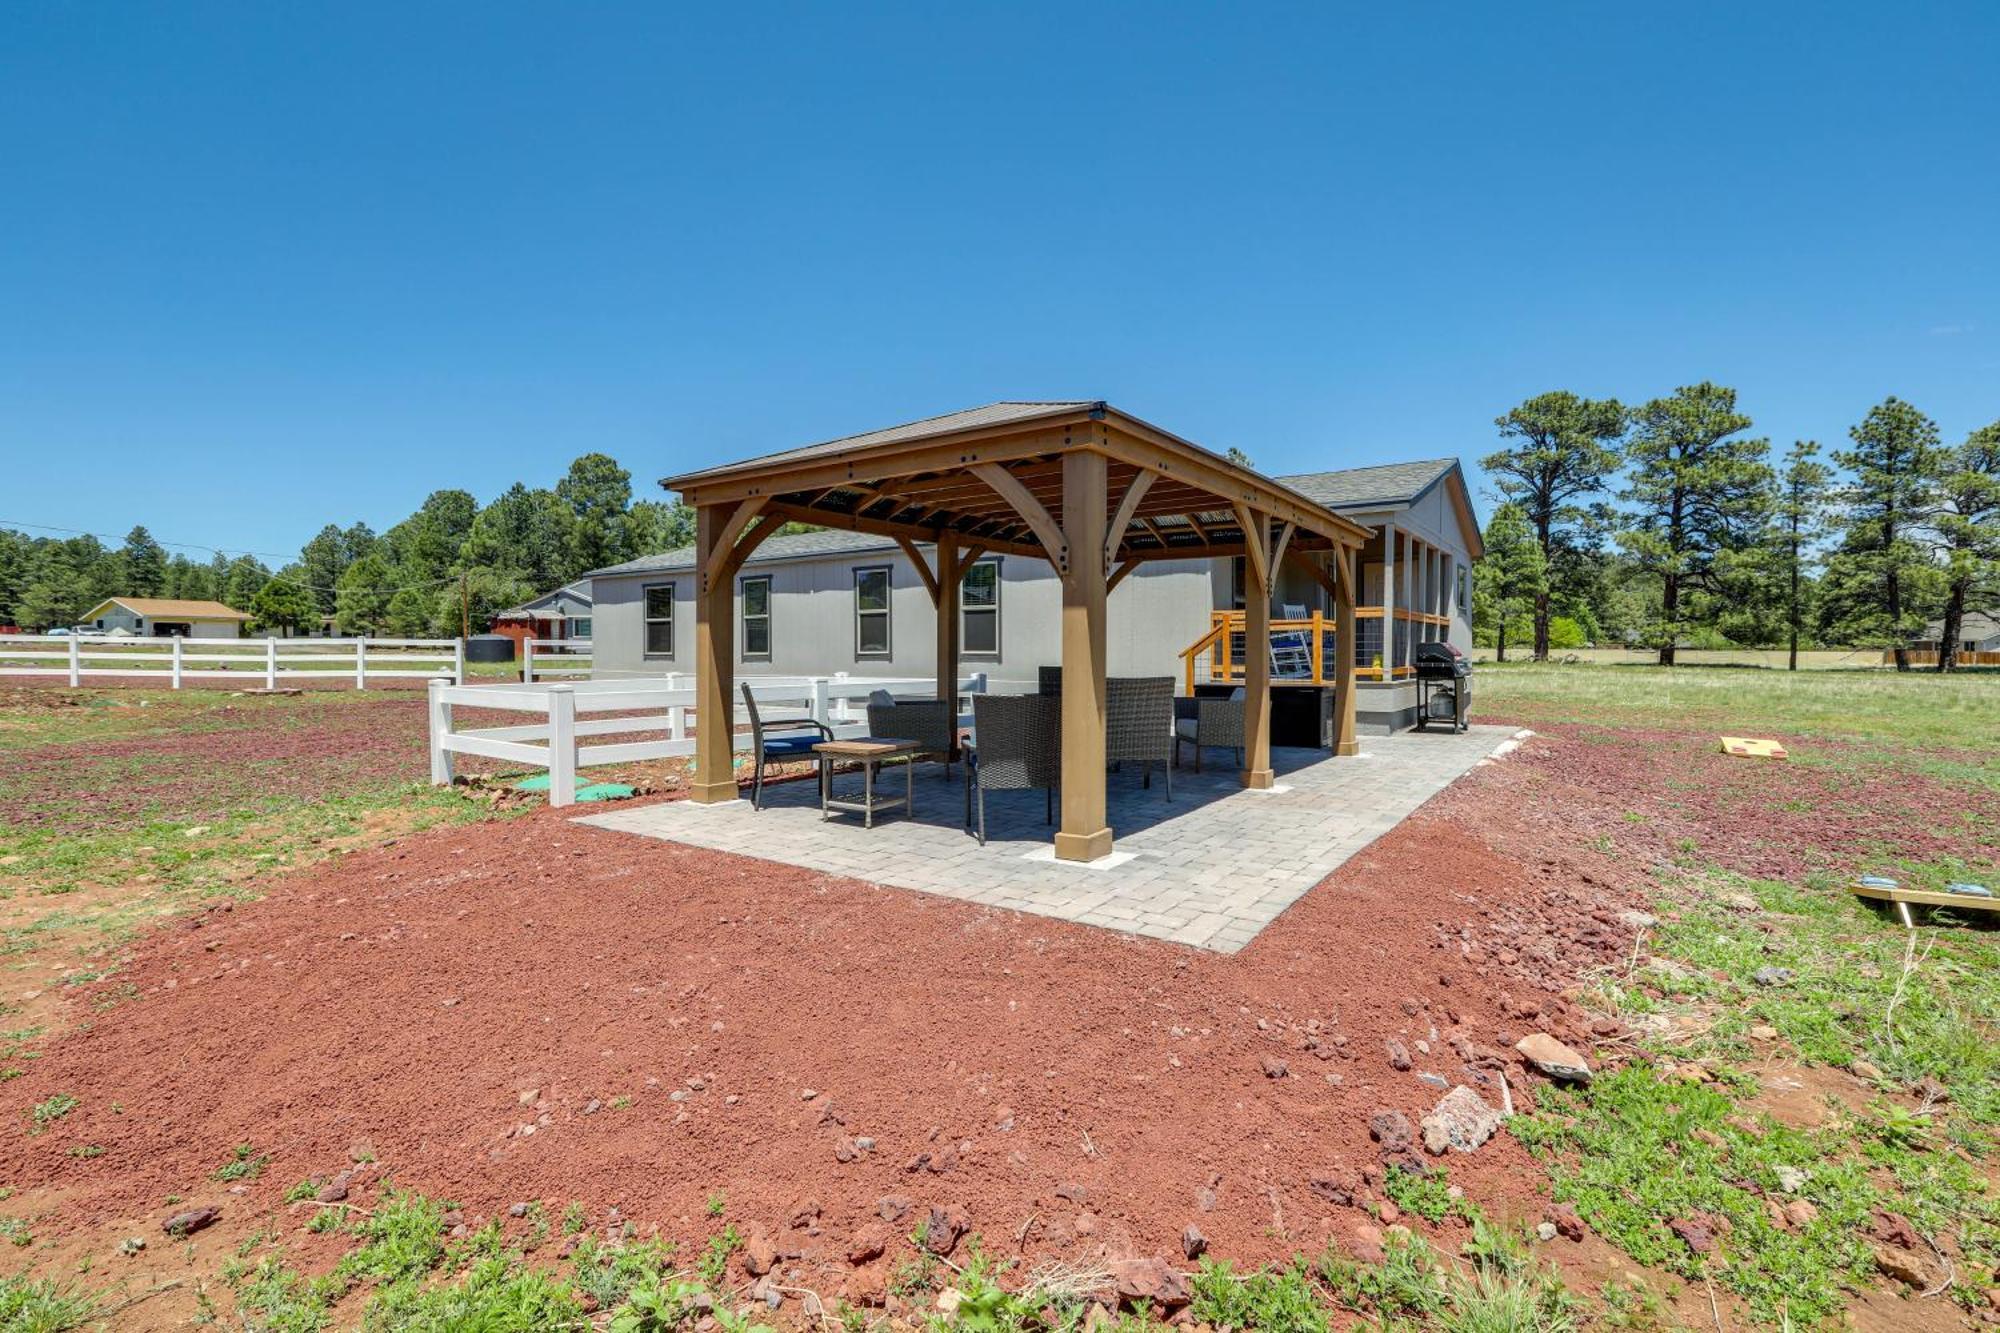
430, 675, 986, 805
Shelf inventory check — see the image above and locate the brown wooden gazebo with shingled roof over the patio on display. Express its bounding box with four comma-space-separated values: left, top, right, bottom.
662, 402, 1368, 861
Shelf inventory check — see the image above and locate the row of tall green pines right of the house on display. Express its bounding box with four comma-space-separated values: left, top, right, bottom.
1474, 382, 2000, 671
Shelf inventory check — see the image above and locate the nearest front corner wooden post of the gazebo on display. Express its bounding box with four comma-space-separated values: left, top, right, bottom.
1048, 448, 1112, 861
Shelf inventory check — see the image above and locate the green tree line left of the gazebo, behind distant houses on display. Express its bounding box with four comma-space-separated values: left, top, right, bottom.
0, 454, 712, 638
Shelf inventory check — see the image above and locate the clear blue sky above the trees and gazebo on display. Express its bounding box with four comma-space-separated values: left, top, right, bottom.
0, 0, 2000, 554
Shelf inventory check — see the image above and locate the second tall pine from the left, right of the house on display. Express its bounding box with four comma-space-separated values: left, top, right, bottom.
1620, 380, 1772, 667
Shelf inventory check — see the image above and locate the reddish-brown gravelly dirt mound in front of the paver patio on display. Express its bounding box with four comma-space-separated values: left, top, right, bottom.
0, 747, 1632, 1269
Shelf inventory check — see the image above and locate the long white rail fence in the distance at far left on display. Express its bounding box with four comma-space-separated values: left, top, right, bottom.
0, 634, 466, 691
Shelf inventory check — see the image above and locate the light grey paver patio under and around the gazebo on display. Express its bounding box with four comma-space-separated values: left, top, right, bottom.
576, 727, 1518, 953
